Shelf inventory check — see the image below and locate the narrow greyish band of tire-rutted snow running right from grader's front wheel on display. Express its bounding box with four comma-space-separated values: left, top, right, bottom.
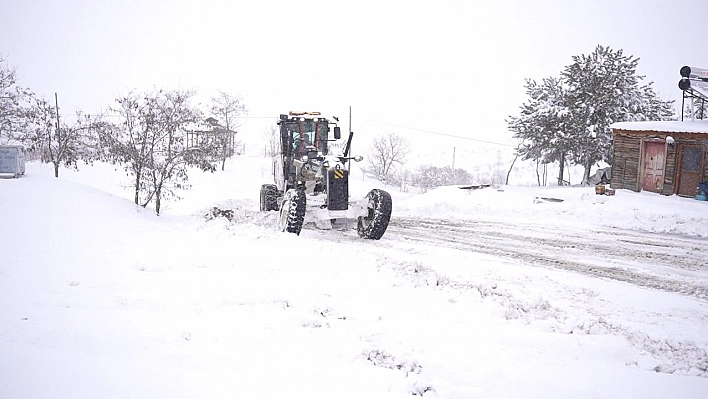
387, 218, 708, 299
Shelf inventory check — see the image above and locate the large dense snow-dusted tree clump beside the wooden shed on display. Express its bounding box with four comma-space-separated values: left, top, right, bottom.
507, 46, 675, 185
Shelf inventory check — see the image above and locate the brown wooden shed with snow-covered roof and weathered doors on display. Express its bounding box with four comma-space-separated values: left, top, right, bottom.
610, 120, 708, 197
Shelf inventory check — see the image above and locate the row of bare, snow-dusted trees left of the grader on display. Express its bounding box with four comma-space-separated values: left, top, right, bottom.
0, 54, 246, 215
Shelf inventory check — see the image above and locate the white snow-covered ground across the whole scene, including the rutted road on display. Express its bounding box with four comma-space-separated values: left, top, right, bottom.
0, 156, 708, 399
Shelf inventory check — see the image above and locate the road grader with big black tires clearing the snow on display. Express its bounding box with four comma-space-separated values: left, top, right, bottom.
260, 112, 392, 240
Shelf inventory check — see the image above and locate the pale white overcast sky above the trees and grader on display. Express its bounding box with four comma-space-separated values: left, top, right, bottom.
0, 0, 708, 164
